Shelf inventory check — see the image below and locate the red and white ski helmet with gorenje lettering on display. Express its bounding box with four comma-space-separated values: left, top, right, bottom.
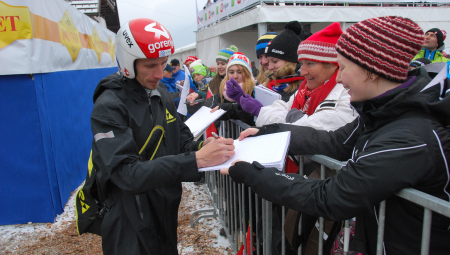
116, 18, 175, 79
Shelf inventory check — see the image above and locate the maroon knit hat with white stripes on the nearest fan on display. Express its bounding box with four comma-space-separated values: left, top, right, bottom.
336, 16, 425, 82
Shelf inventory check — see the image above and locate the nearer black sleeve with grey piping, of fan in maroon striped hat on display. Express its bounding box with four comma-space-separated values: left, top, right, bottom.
239, 130, 433, 220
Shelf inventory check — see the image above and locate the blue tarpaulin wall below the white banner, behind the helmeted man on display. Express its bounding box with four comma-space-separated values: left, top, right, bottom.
0, 67, 117, 225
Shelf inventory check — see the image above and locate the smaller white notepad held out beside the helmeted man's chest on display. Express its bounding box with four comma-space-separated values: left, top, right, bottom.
185, 106, 226, 137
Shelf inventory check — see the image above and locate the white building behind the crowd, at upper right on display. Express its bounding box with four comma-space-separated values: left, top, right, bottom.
177, 0, 450, 67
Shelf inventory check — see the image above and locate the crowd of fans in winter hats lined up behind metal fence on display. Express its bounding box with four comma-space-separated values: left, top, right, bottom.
161, 17, 450, 254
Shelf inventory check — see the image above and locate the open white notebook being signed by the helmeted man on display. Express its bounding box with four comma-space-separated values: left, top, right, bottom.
198, 131, 291, 172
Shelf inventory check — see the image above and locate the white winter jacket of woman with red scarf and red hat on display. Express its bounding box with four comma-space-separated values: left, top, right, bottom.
256, 83, 358, 131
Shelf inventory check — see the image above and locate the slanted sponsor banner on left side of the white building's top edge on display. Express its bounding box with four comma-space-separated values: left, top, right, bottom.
197, 0, 260, 29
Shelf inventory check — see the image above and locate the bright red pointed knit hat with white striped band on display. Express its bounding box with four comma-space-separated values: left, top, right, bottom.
297, 22, 342, 65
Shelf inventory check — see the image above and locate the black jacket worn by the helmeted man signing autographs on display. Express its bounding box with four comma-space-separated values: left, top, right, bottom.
91, 74, 201, 254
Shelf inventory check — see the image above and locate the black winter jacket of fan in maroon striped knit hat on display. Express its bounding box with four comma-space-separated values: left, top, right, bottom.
230, 64, 450, 255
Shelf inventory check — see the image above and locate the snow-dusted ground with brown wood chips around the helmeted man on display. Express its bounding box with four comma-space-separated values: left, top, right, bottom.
0, 183, 233, 255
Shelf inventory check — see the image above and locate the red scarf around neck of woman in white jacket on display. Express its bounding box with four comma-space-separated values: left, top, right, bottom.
291, 71, 338, 115
